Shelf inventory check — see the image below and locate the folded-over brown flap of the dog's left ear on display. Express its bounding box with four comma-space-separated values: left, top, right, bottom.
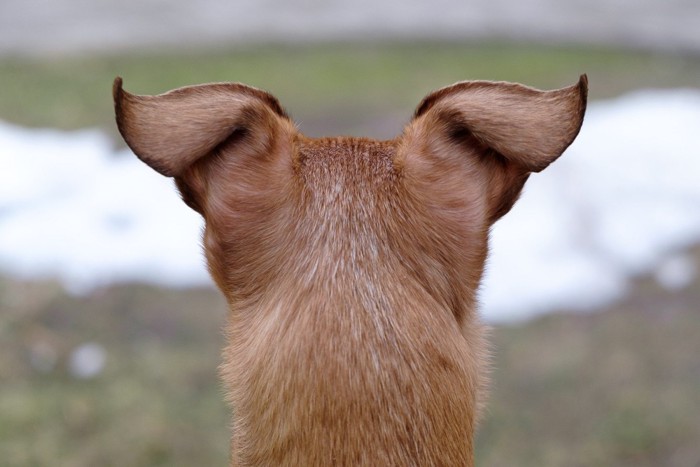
113, 78, 289, 177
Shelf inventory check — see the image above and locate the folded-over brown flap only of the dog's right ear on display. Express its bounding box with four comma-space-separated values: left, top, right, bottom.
414, 75, 588, 172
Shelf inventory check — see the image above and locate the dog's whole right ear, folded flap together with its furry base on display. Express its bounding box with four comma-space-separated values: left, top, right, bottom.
396, 75, 588, 223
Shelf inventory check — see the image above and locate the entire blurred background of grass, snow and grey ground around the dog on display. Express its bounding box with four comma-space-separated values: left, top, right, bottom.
0, 0, 700, 467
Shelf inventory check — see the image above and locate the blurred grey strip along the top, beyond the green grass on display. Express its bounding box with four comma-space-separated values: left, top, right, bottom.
0, 0, 700, 55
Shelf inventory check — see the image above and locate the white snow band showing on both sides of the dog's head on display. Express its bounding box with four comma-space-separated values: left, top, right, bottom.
0, 90, 700, 321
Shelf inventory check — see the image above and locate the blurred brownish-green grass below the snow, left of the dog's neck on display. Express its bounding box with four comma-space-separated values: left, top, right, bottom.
0, 280, 229, 467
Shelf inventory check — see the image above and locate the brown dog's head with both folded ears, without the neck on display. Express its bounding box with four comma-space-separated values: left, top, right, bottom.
114, 75, 587, 313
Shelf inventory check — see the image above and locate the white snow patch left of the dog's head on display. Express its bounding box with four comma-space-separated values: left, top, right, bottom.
0, 125, 209, 292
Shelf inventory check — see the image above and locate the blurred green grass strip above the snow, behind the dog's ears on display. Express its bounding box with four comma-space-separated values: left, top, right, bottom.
0, 43, 700, 136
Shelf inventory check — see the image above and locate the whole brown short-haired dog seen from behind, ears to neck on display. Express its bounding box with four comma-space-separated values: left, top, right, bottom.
114, 76, 587, 466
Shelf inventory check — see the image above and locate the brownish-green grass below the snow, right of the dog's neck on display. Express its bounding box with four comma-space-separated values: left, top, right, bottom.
477, 266, 700, 467
